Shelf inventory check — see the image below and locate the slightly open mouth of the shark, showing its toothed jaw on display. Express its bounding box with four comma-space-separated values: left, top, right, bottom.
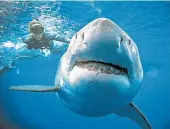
74, 61, 128, 75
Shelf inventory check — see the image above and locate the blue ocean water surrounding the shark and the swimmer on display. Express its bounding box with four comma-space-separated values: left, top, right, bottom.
0, 1, 170, 129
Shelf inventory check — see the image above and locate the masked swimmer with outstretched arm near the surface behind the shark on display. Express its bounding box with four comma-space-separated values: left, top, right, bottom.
22, 19, 70, 50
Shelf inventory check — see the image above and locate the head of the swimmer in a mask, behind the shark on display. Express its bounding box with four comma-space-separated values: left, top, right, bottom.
28, 20, 44, 34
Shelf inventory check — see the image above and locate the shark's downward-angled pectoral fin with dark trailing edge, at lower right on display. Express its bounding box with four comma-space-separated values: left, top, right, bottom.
116, 103, 152, 129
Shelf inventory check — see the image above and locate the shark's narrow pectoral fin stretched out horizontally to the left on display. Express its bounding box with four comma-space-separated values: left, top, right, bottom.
9, 85, 60, 92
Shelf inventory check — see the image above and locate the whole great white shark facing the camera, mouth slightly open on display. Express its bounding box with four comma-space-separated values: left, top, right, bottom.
10, 18, 152, 129
